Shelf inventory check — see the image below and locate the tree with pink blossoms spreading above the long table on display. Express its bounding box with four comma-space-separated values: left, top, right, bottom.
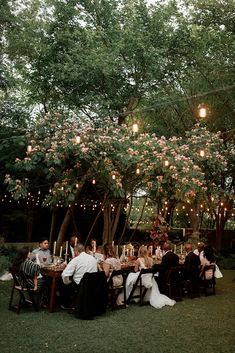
6, 113, 232, 243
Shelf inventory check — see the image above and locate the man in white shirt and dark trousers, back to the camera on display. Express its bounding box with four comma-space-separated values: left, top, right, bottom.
60, 243, 98, 307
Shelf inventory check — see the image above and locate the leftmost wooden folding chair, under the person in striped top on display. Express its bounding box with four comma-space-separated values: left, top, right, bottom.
9, 272, 39, 314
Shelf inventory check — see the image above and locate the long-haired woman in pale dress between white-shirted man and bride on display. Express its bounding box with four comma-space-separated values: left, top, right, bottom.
102, 243, 123, 287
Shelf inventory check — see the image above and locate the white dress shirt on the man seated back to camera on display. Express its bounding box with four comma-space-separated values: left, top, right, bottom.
62, 251, 97, 284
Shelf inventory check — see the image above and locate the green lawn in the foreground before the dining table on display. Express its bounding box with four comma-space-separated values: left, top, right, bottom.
0, 270, 235, 353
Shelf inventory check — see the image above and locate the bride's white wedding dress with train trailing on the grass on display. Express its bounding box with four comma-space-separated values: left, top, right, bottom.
124, 259, 176, 309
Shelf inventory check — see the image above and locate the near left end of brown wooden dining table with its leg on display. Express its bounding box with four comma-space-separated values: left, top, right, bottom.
41, 265, 64, 313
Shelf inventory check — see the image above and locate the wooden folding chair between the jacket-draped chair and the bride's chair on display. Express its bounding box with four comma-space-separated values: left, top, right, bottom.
108, 268, 130, 310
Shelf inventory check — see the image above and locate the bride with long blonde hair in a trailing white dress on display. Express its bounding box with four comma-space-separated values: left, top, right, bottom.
126, 245, 176, 309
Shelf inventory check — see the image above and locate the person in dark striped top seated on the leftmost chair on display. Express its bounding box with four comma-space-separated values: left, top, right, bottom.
10, 247, 48, 305
